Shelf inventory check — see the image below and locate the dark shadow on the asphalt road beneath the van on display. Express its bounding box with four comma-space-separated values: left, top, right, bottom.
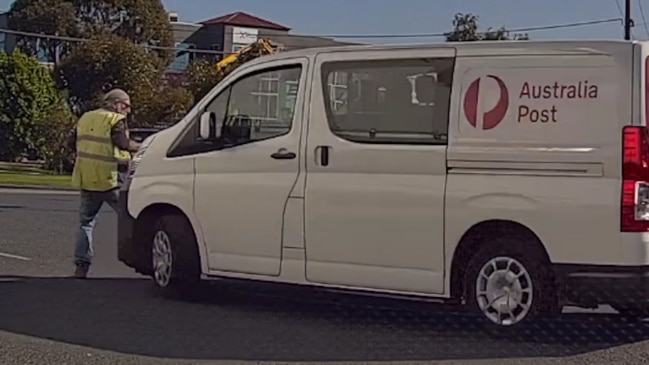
0, 276, 649, 361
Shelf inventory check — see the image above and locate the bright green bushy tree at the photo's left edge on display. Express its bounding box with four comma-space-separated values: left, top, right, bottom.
0, 52, 61, 160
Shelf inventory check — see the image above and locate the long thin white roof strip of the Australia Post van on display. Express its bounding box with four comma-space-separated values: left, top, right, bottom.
248, 40, 643, 65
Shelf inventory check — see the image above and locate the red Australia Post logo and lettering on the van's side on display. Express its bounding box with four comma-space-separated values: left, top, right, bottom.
462, 75, 599, 130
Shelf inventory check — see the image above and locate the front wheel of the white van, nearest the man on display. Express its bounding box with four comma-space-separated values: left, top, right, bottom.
150, 215, 201, 298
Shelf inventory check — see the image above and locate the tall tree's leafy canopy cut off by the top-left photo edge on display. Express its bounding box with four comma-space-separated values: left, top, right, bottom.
9, 0, 175, 66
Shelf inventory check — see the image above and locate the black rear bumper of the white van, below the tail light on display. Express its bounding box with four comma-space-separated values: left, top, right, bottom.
554, 264, 649, 308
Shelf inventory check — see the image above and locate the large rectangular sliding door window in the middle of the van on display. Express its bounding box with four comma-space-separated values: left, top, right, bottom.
321, 58, 455, 145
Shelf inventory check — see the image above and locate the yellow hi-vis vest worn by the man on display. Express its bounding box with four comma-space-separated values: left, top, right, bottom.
72, 109, 124, 191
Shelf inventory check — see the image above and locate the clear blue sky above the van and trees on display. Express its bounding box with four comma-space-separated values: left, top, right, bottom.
0, 0, 649, 43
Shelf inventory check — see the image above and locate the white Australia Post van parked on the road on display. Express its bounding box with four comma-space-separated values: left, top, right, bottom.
118, 41, 649, 328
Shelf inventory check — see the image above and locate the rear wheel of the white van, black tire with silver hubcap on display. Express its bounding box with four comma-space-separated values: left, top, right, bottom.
464, 239, 558, 333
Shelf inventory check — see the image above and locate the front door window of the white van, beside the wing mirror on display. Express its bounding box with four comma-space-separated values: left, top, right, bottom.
168, 65, 302, 157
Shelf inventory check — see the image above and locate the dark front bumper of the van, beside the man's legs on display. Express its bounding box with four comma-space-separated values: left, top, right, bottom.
117, 189, 153, 275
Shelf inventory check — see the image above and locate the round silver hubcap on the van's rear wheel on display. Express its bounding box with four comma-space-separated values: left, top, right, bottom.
476, 257, 534, 326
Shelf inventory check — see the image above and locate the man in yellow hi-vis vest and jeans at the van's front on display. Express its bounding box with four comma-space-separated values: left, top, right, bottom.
68, 89, 140, 279
